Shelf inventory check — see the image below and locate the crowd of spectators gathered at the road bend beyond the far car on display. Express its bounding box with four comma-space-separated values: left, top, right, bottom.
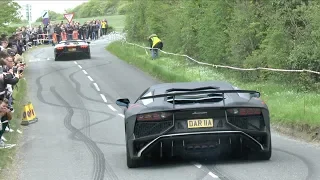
19, 20, 108, 48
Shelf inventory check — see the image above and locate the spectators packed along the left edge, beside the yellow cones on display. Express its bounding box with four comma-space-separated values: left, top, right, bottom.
0, 30, 26, 148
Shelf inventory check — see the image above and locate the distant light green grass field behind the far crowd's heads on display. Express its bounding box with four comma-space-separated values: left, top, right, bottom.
10, 15, 125, 31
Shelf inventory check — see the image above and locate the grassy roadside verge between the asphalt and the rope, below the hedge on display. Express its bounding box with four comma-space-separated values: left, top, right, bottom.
106, 42, 320, 139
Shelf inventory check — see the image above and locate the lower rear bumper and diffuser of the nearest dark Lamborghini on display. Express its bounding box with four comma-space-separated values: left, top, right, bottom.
128, 131, 270, 159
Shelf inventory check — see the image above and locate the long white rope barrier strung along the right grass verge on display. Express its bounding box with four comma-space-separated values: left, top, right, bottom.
105, 32, 320, 75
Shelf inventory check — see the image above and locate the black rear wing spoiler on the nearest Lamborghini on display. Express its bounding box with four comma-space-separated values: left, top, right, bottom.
140, 89, 261, 107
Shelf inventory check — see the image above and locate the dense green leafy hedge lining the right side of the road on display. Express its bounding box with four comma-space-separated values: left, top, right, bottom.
125, 0, 320, 90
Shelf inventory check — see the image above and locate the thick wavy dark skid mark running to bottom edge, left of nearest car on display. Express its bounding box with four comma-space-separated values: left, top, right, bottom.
50, 87, 117, 180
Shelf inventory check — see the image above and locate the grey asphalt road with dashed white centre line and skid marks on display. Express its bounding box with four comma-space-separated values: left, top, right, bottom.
12, 37, 320, 180
